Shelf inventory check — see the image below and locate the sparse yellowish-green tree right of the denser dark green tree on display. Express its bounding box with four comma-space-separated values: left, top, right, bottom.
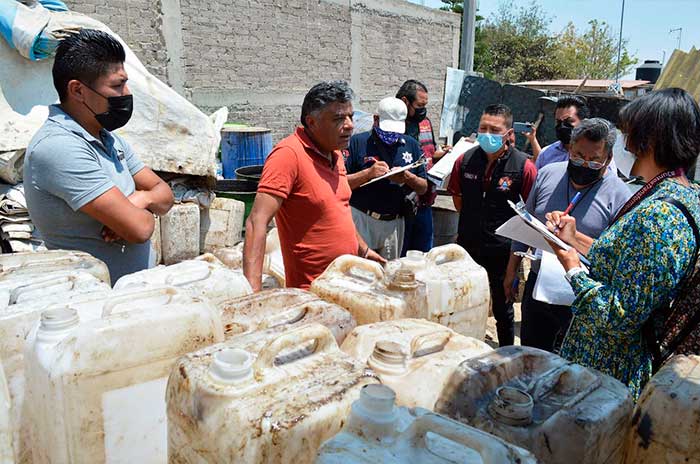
556, 19, 637, 79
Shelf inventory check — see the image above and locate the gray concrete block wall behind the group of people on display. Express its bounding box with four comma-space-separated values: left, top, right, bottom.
67, 0, 460, 142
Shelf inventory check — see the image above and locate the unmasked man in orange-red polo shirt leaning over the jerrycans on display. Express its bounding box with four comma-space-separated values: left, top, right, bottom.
243, 81, 384, 291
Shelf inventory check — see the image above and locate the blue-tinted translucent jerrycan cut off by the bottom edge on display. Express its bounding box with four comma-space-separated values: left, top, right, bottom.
316, 385, 537, 464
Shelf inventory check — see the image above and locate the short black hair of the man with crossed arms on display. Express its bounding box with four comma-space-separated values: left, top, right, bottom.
52, 29, 126, 102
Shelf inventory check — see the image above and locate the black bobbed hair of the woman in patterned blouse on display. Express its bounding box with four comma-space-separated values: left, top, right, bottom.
619, 88, 700, 171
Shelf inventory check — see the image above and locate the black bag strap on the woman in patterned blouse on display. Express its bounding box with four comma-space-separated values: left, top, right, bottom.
642, 196, 700, 372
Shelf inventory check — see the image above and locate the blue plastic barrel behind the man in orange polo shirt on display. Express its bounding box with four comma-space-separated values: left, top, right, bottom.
221, 125, 272, 179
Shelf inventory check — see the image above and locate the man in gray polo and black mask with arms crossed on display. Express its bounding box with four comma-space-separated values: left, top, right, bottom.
24, 29, 173, 283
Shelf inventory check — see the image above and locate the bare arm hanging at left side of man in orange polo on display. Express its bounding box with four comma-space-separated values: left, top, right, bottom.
243, 192, 284, 292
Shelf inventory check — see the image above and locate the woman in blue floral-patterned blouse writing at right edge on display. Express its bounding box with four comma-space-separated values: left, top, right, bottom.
547, 89, 700, 400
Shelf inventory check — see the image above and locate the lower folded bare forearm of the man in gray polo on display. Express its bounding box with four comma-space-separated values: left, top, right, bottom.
80, 187, 155, 243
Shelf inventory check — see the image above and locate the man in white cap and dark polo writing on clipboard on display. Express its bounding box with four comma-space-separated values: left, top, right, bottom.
344, 97, 428, 259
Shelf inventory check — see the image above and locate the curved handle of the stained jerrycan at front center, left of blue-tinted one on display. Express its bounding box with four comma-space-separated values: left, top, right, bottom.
254, 324, 338, 380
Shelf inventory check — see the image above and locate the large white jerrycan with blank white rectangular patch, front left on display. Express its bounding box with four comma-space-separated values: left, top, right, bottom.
25, 297, 224, 464
